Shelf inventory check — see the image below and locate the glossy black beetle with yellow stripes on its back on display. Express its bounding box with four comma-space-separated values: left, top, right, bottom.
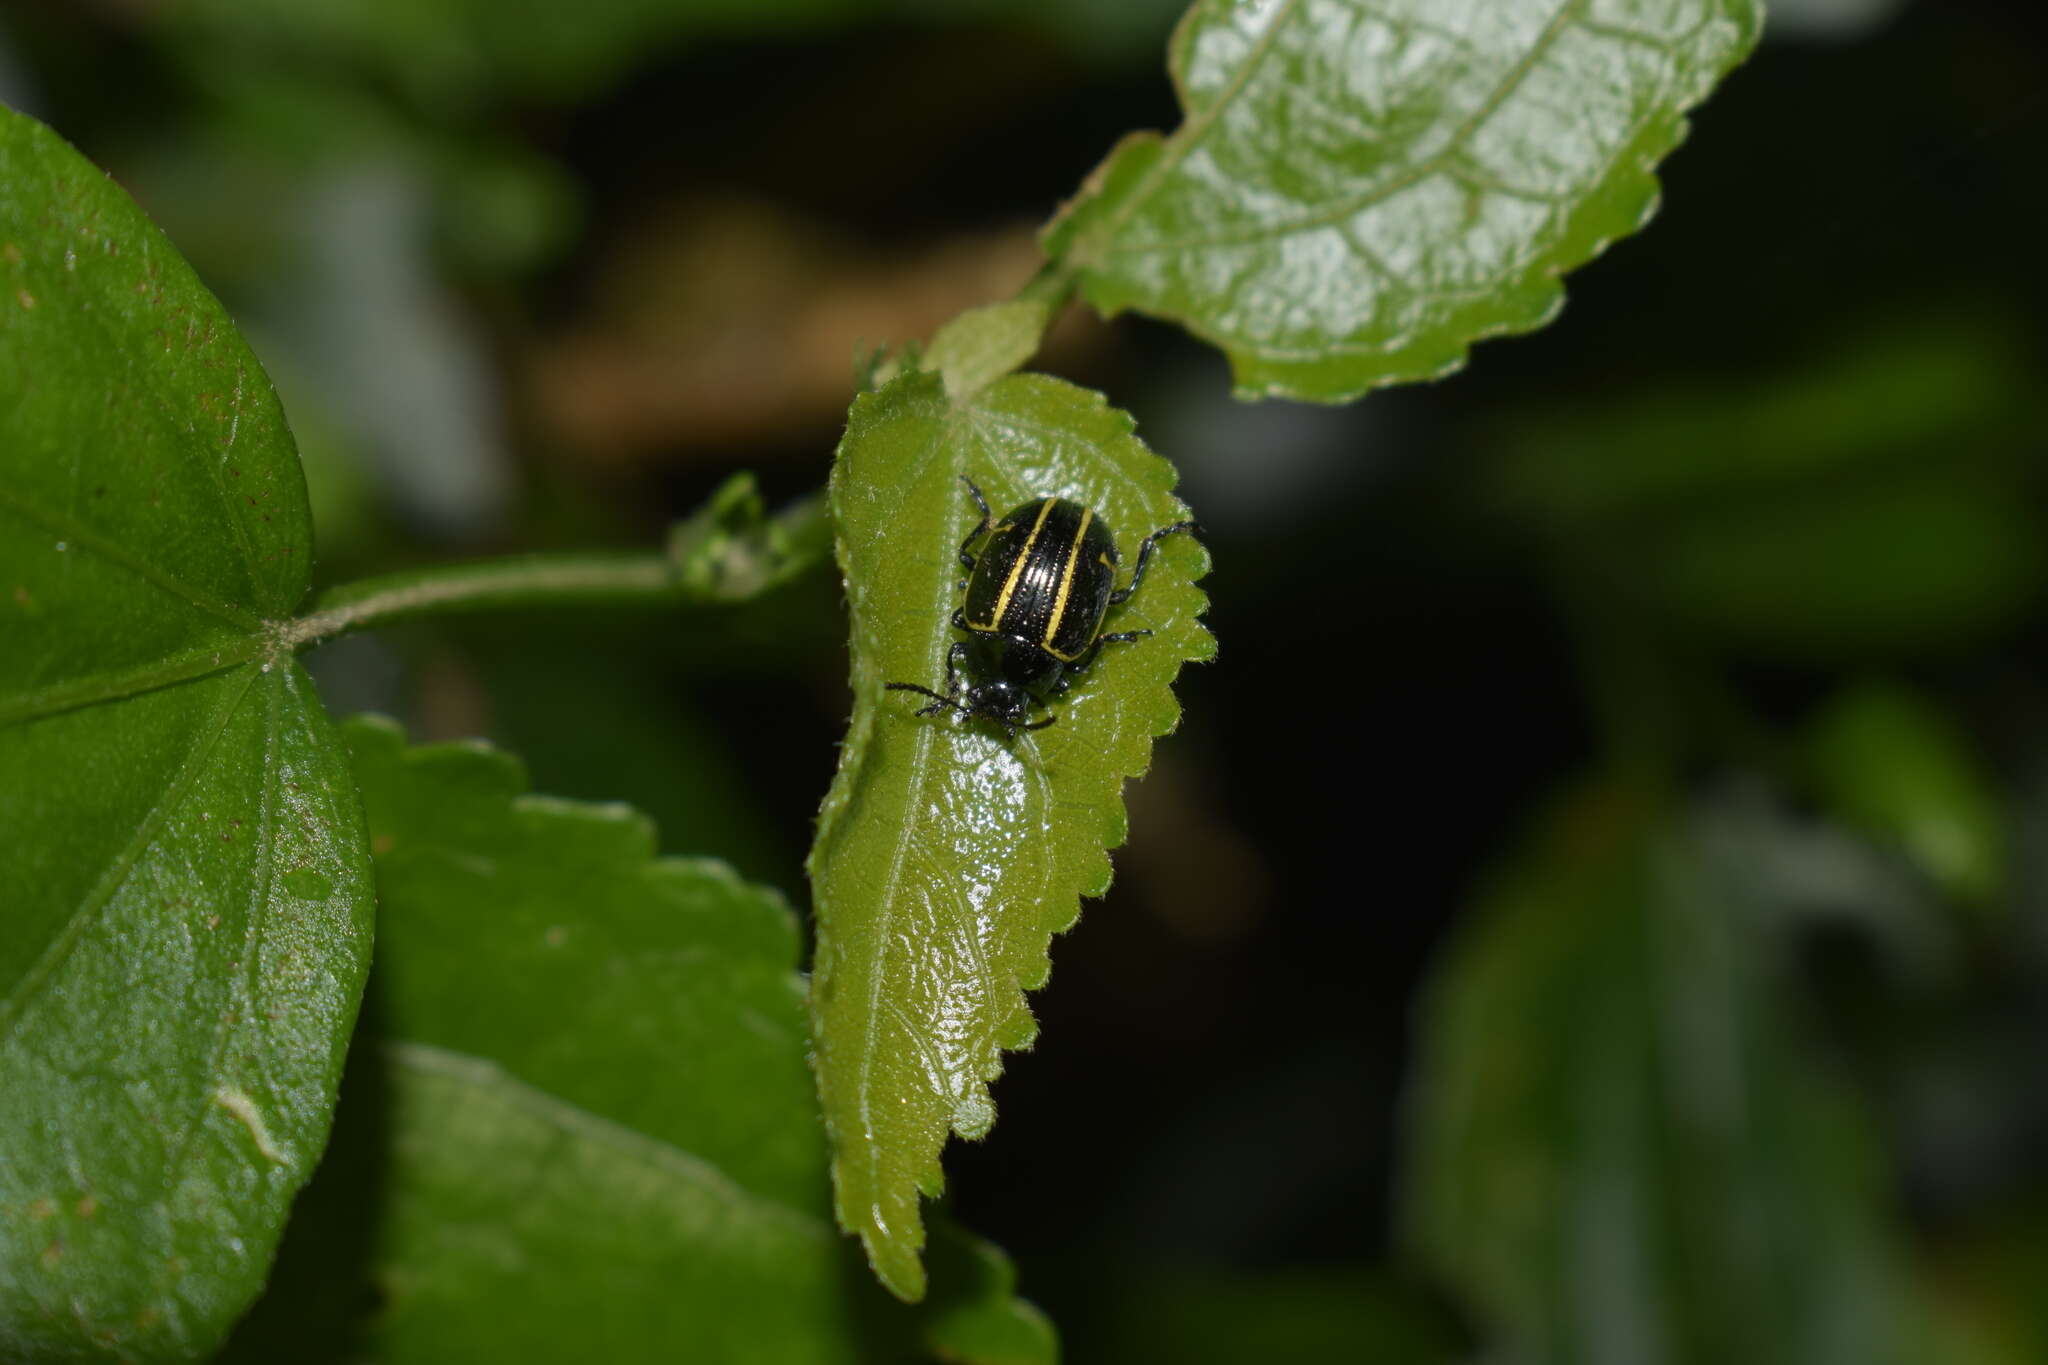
887, 475, 1200, 737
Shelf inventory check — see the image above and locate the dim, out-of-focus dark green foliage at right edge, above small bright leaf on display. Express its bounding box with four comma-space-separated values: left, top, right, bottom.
1493, 311, 2048, 663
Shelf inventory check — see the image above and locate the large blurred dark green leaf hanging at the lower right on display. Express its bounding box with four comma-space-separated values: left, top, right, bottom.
1407, 786, 1907, 1365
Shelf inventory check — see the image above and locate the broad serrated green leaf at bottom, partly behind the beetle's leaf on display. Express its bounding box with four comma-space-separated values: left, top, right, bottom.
307, 718, 1055, 1365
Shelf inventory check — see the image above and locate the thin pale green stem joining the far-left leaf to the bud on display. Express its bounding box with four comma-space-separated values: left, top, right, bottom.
272, 553, 686, 649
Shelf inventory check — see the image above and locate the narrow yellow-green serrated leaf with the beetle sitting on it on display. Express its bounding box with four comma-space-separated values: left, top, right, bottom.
811, 372, 1214, 1300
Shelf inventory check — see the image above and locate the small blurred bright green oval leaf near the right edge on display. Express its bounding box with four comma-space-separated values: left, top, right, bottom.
1808, 681, 2007, 905
